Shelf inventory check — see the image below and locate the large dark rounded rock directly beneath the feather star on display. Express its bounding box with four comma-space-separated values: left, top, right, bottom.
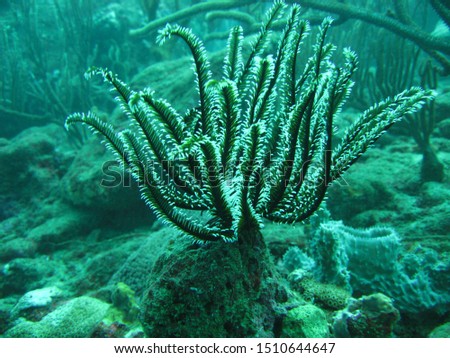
141, 234, 287, 337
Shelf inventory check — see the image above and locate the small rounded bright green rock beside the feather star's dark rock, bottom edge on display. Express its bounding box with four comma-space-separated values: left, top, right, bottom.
281, 304, 329, 338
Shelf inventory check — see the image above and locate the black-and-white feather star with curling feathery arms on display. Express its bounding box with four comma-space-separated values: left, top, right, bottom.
66, 1, 431, 245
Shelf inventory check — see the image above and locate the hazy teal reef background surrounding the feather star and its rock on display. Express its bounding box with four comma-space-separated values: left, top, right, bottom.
0, 0, 450, 338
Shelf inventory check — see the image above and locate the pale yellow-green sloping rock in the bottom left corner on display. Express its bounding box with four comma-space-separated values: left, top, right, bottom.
5, 296, 110, 338
